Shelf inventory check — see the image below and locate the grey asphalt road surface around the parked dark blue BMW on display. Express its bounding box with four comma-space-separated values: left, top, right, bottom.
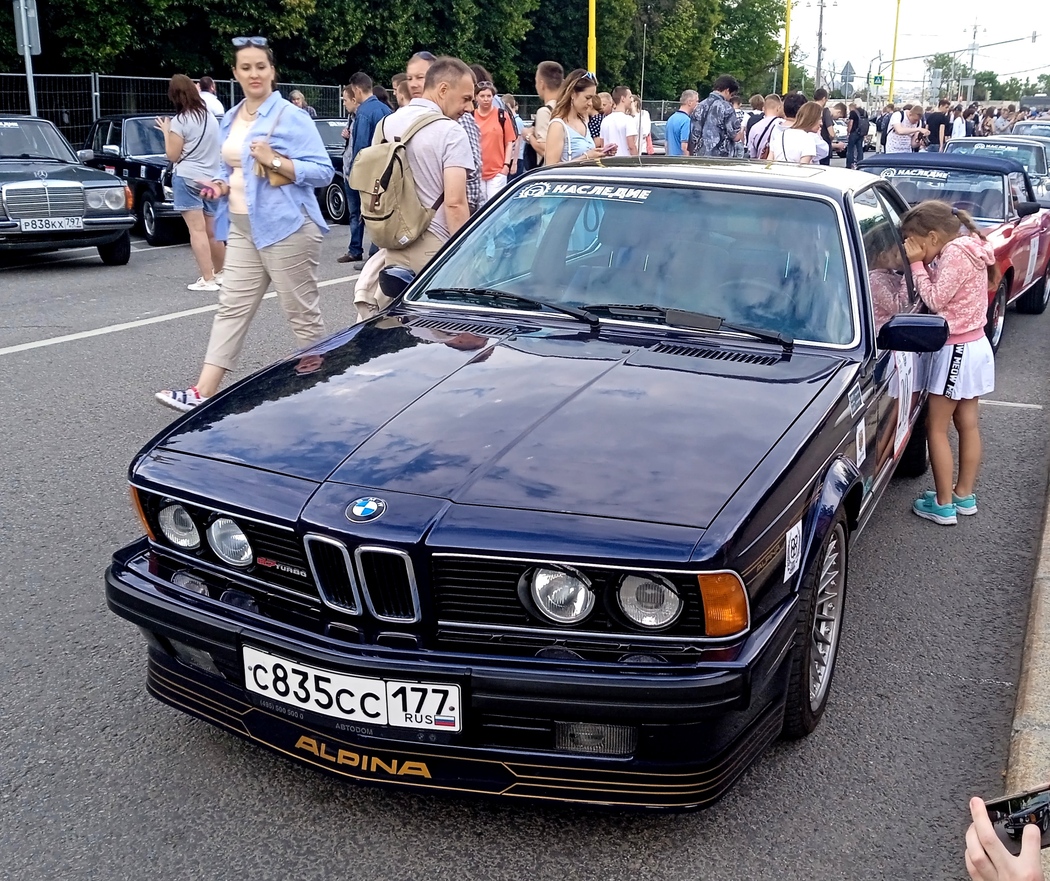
0, 227, 1050, 881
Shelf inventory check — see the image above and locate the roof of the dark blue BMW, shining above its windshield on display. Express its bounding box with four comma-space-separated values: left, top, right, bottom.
526, 156, 879, 197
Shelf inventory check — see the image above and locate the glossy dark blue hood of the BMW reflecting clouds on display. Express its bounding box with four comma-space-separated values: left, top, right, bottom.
158, 318, 842, 527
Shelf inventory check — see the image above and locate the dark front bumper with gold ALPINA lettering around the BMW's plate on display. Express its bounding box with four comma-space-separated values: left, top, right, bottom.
106, 542, 797, 809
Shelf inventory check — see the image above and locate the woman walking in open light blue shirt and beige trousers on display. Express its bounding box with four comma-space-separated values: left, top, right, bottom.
155, 37, 334, 411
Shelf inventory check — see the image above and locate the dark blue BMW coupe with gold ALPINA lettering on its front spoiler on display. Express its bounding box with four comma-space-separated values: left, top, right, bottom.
106, 159, 947, 807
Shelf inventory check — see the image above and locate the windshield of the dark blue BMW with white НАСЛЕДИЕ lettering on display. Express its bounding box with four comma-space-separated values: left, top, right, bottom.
414, 181, 854, 344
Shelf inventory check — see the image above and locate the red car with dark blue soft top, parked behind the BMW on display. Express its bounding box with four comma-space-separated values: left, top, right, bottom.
860, 151, 1050, 350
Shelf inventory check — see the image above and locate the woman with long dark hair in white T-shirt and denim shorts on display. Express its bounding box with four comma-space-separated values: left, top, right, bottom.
156, 74, 226, 291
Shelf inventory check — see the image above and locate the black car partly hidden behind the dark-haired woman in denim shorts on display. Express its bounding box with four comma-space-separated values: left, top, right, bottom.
81, 113, 186, 245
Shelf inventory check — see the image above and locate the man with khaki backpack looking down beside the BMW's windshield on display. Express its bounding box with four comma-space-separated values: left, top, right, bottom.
351, 57, 475, 272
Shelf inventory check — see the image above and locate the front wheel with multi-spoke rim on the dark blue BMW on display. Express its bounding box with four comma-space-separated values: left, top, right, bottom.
783, 508, 849, 739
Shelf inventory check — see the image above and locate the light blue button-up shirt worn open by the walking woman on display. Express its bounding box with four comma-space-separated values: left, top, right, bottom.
215, 91, 335, 248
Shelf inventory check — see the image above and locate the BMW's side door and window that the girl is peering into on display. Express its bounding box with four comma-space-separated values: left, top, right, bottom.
854, 183, 925, 501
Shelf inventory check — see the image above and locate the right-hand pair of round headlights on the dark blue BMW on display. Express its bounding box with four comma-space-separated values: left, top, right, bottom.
526, 567, 685, 630
